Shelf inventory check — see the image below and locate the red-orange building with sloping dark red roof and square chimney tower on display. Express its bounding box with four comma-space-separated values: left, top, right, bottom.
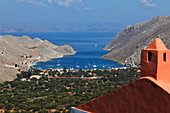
71, 38, 170, 113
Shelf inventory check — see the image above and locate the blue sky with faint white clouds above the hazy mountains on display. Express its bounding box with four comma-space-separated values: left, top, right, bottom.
0, 0, 170, 30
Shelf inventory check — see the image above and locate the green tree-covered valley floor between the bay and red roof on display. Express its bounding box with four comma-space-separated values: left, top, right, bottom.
0, 68, 139, 113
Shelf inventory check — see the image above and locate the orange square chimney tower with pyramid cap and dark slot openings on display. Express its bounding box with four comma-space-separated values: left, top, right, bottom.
141, 38, 170, 83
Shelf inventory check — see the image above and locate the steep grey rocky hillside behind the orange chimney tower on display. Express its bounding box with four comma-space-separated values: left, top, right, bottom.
103, 16, 170, 65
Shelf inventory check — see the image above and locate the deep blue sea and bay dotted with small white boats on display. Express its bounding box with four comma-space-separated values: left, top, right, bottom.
1, 32, 124, 69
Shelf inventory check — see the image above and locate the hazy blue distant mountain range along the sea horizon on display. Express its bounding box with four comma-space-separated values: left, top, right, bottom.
0, 22, 124, 33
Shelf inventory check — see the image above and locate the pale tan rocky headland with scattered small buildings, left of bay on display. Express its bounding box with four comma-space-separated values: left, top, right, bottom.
0, 35, 76, 82
